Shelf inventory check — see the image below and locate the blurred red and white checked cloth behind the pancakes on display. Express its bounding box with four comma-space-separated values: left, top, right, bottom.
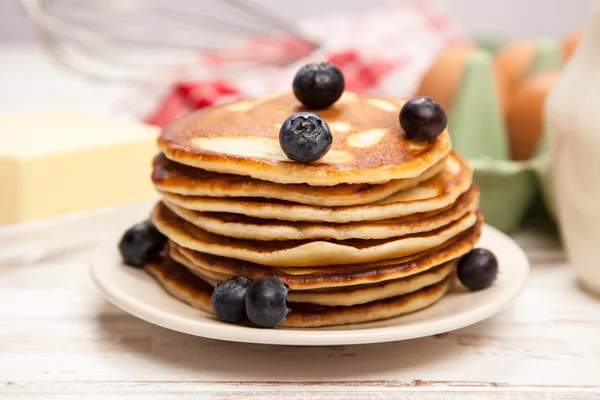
146, 1, 463, 126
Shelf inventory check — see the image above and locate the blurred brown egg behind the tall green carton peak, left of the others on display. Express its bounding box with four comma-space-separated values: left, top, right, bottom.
417, 43, 506, 113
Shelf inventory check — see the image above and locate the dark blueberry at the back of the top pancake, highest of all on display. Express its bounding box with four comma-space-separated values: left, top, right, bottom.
293, 62, 345, 110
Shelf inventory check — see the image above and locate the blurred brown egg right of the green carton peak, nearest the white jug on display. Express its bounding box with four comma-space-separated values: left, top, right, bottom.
506, 71, 559, 161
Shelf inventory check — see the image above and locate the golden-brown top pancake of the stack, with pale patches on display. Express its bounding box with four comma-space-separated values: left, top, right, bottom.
158, 92, 451, 186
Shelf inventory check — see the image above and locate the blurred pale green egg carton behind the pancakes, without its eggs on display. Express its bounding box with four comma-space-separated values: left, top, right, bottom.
448, 41, 560, 232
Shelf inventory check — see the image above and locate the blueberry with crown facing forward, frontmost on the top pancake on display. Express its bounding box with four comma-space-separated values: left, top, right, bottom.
279, 112, 333, 163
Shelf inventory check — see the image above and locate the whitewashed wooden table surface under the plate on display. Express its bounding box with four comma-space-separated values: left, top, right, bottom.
0, 205, 600, 399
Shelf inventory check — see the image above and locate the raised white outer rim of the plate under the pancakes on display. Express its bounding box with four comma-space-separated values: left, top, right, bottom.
89, 224, 530, 346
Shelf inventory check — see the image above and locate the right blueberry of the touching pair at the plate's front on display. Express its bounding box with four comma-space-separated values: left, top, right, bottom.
246, 277, 290, 328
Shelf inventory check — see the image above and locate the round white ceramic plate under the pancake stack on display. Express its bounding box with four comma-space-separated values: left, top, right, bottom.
91, 225, 529, 346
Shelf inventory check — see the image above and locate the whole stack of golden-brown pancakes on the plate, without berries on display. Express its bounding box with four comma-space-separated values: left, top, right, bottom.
146, 93, 482, 327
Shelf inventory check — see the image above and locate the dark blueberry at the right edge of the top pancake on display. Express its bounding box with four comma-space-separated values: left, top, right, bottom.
400, 96, 448, 142
